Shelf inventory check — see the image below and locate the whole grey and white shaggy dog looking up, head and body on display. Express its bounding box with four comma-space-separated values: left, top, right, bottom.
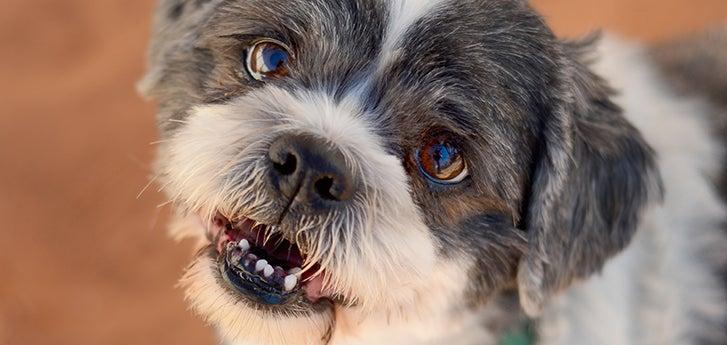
140, 0, 727, 345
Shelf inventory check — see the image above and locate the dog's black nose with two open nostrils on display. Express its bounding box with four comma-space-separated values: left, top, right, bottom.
268, 135, 355, 206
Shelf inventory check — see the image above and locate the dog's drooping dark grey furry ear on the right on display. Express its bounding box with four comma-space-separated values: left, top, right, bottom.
517, 40, 661, 316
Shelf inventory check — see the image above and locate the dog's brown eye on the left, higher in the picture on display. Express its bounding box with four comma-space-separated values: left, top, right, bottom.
246, 40, 290, 81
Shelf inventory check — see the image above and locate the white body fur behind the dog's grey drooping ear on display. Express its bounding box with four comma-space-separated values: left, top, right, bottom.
541, 39, 727, 345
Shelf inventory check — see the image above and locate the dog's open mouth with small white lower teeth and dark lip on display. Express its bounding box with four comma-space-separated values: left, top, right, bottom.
203, 214, 334, 305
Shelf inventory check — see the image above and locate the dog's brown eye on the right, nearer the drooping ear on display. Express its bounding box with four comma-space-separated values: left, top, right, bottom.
417, 134, 469, 184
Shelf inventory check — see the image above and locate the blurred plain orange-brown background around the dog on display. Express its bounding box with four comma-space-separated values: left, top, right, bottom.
0, 0, 727, 345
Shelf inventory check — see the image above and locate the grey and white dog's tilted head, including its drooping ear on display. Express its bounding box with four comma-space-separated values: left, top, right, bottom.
145, 0, 658, 344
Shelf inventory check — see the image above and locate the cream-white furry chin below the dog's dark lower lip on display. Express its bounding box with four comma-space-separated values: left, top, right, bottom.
182, 253, 334, 345
